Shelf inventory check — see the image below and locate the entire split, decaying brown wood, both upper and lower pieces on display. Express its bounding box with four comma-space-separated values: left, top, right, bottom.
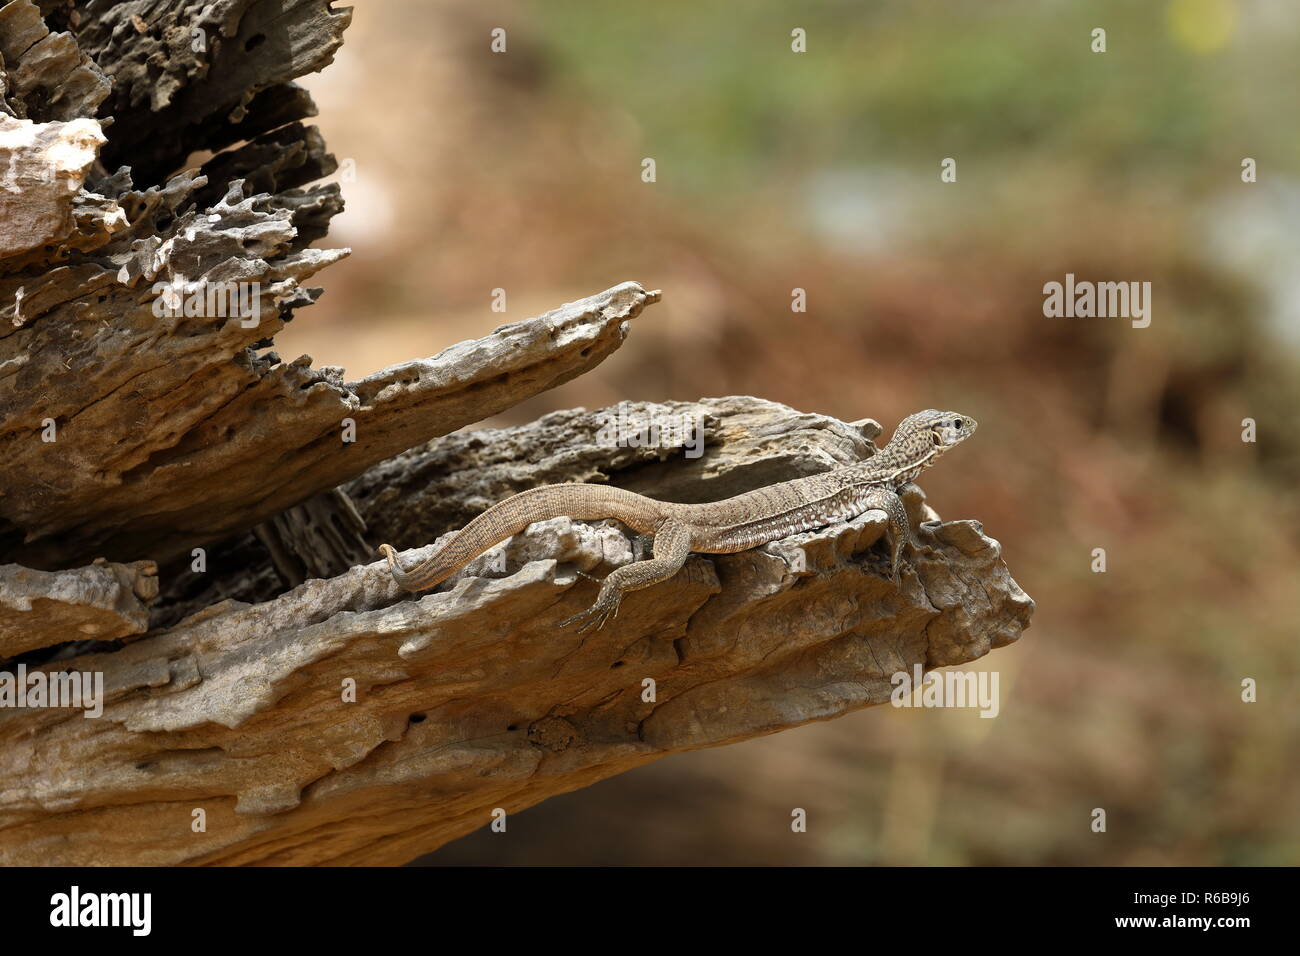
0, 0, 1032, 864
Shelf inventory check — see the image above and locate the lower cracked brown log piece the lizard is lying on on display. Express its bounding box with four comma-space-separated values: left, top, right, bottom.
0, 399, 1032, 864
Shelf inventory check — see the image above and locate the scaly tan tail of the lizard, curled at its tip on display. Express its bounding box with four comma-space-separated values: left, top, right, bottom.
380, 484, 666, 591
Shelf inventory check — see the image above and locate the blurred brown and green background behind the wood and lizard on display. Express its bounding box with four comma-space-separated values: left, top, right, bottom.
277, 0, 1300, 865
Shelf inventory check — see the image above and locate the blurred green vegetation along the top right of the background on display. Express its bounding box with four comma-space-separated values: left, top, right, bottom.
534, 0, 1300, 202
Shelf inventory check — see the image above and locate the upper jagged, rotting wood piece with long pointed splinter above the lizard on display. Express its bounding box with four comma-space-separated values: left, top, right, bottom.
0, 0, 654, 567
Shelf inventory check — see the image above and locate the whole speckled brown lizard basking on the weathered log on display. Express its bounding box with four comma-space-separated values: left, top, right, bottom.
378, 408, 978, 633
